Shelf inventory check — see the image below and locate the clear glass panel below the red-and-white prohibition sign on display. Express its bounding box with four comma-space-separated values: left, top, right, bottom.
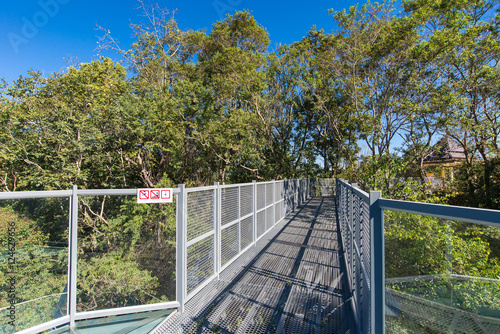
77, 196, 175, 312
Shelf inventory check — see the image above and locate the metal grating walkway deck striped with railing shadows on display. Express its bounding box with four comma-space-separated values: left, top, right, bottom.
156, 197, 354, 334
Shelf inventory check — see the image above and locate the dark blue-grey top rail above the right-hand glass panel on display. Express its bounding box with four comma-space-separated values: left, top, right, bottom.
376, 198, 500, 227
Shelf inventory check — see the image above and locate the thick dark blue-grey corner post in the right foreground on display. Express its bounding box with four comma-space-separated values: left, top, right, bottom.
370, 191, 385, 334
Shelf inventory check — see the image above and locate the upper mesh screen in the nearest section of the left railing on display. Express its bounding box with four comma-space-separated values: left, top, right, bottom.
187, 190, 214, 241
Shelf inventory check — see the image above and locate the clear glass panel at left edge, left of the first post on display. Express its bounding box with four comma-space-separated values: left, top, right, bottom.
0, 198, 69, 333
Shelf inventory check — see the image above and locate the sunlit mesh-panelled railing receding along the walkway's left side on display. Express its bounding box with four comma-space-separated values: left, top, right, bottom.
176, 179, 312, 312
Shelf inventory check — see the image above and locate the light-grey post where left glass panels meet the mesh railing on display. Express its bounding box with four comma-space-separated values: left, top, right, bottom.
175, 184, 187, 312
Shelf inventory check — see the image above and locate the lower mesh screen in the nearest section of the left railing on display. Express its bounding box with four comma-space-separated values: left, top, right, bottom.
187, 235, 214, 293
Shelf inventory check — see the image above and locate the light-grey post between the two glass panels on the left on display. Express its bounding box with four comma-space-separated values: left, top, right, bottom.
68, 185, 78, 327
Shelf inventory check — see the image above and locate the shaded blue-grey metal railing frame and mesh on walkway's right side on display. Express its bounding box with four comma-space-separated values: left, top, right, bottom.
337, 179, 500, 334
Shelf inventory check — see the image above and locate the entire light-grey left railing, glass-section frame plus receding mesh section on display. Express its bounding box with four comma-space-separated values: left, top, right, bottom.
0, 179, 313, 334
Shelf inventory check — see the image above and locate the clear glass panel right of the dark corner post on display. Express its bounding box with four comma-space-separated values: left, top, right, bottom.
384, 211, 500, 333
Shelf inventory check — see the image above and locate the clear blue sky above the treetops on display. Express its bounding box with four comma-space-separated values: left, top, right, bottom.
0, 0, 364, 81
